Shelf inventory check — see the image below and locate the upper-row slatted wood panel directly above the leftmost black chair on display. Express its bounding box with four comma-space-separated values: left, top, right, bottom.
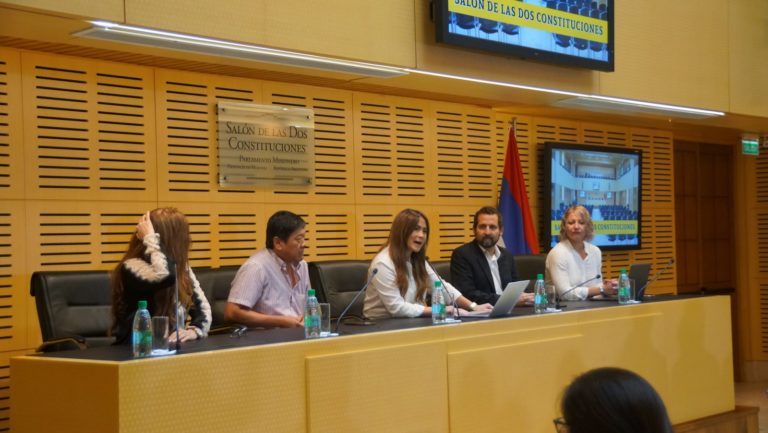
22, 52, 156, 200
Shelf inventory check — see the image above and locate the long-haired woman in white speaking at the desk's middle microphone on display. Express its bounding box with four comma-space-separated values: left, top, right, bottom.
363, 209, 491, 319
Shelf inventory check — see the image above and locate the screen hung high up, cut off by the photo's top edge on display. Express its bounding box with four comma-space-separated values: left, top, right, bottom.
432, 0, 614, 71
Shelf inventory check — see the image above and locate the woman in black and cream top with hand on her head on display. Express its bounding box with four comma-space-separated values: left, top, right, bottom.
112, 207, 211, 344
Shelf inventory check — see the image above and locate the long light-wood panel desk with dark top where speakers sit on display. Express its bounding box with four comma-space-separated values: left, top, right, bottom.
11, 296, 734, 433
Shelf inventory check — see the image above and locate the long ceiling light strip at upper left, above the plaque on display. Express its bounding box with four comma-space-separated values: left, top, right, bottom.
73, 21, 408, 78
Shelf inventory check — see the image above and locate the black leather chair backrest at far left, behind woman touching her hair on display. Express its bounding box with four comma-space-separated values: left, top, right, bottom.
30, 271, 114, 347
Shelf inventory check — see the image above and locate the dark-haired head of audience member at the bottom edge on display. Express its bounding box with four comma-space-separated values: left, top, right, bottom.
554, 367, 672, 433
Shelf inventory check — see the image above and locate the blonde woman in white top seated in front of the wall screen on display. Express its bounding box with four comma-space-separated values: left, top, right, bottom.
546, 205, 616, 300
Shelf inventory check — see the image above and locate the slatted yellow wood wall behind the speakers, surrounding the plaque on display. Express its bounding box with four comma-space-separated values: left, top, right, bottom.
0, 48, 675, 428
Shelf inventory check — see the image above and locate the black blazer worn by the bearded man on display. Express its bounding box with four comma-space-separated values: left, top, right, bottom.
451, 240, 518, 304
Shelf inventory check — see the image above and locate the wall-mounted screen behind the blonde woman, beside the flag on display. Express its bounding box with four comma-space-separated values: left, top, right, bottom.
543, 143, 642, 250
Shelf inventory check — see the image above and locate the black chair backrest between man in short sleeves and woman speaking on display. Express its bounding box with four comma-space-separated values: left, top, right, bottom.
309, 260, 370, 318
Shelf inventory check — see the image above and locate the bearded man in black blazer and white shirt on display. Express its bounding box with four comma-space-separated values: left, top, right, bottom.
451, 206, 533, 305
